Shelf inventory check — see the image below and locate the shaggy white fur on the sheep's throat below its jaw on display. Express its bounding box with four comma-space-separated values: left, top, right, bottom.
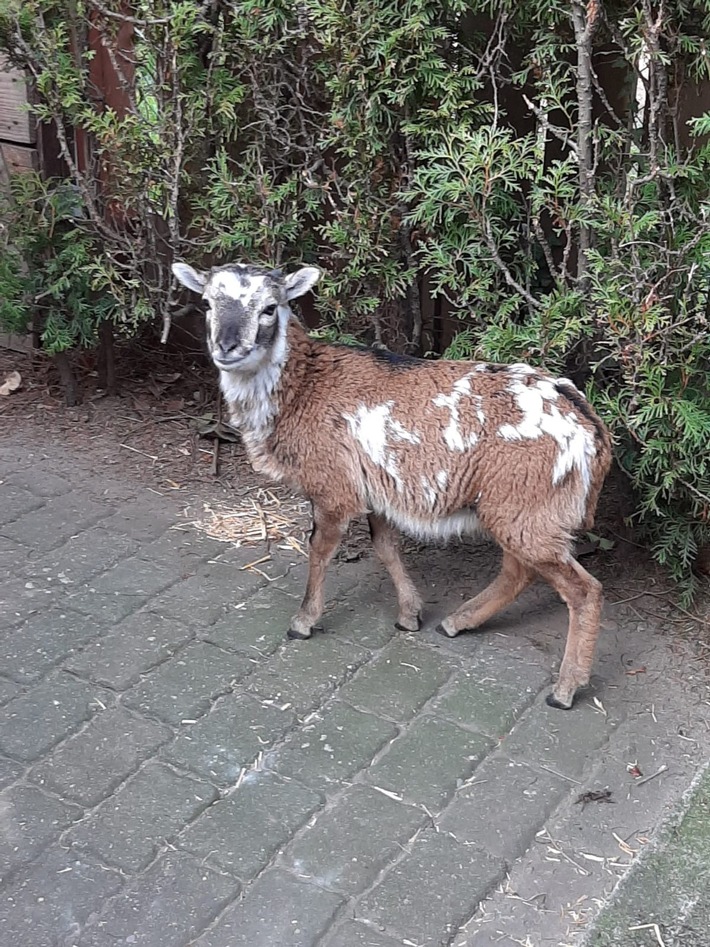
219, 307, 290, 436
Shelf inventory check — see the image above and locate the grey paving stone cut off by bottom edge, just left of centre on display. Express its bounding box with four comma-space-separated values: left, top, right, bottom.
195, 870, 342, 947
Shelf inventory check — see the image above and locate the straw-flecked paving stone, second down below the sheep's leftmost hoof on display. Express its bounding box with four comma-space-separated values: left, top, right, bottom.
264, 701, 397, 790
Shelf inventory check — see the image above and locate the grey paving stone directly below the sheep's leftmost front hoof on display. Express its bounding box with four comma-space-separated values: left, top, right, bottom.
246, 635, 370, 713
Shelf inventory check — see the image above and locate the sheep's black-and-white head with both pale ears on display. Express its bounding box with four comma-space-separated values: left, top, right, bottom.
173, 263, 320, 372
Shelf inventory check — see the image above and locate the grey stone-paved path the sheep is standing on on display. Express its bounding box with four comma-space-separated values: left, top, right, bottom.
0, 436, 710, 947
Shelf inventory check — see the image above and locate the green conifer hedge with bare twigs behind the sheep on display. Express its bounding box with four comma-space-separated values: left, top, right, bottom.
0, 0, 710, 594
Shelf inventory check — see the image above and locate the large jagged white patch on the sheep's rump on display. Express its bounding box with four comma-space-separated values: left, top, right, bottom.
498, 378, 596, 500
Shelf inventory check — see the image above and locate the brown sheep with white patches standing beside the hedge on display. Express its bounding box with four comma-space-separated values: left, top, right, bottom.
173, 263, 611, 709
